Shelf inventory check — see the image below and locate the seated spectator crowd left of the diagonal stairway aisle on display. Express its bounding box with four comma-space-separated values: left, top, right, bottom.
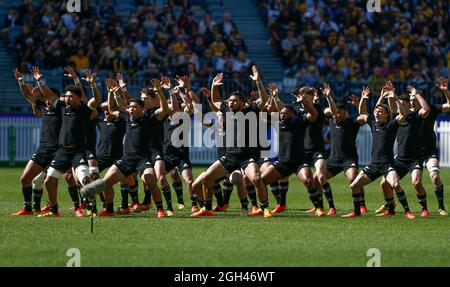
3, 0, 251, 92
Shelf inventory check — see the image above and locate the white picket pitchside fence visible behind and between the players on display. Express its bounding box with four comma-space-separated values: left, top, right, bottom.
0, 115, 450, 167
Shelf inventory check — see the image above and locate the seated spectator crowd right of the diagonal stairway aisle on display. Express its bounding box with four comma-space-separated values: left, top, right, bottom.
258, 0, 450, 88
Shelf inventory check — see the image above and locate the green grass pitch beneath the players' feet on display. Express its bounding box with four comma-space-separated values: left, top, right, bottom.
0, 168, 450, 267
